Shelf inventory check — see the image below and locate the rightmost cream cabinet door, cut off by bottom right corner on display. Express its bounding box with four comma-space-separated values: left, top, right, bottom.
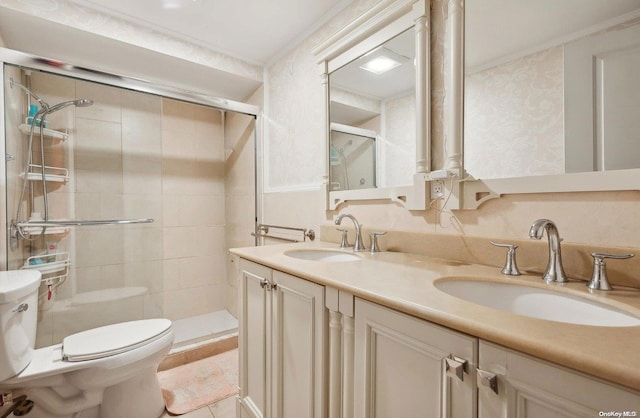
478, 341, 640, 418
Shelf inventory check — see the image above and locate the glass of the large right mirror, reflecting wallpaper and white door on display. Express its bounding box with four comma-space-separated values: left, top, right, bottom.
464, 0, 640, 179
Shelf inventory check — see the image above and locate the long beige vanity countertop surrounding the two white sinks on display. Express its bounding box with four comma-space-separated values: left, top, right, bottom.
230, 241, 640, 390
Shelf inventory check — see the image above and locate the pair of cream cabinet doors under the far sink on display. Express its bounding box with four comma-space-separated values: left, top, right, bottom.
238, 259, 327, 418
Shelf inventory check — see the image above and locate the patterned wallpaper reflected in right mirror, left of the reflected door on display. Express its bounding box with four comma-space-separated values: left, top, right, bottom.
464, 46, 564, 179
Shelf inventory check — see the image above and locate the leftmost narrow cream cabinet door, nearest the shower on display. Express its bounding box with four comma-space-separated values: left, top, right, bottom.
238, 260, 272, 418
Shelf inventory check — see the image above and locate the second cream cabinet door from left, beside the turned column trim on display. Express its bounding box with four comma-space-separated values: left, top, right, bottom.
271, 271, 327, 418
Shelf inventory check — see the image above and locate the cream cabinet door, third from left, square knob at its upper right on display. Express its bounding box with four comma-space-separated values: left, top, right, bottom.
356, 299, 477, 418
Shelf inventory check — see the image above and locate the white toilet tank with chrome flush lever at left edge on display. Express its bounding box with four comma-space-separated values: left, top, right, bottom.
0, 270, 41, 382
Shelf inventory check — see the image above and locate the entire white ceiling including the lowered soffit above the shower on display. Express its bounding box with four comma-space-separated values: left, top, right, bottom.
0, 0, 353, 101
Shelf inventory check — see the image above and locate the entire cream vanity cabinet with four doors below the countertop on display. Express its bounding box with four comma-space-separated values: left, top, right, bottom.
237, 255, 640, 418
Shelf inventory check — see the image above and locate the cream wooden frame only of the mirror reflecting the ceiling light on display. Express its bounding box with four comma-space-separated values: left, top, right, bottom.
313, 0, 431, 210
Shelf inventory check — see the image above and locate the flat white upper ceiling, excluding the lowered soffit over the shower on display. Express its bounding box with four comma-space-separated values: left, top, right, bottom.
71, 0, 352, 65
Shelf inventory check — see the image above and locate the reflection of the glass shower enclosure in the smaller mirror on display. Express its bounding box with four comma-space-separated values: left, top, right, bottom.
329, 123, 376, 191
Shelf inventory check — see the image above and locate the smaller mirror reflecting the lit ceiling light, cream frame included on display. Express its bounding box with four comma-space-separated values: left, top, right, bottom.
314, 0, 430, 210
